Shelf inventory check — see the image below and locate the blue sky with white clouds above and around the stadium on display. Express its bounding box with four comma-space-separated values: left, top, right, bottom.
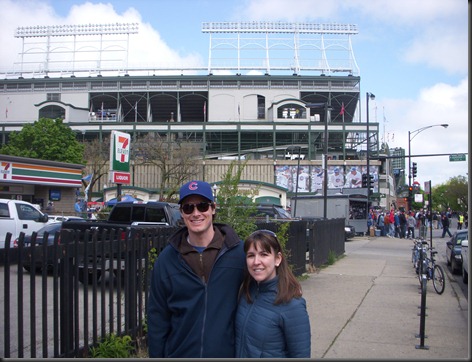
0, 0, 469, 187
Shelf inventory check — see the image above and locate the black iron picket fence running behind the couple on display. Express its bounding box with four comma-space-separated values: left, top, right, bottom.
0, 219, 344, 358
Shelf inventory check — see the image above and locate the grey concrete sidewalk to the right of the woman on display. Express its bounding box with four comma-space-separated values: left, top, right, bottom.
302, 231, 469, 359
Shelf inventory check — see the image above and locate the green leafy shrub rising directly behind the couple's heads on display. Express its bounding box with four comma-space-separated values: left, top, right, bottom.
215, 160, 258, 240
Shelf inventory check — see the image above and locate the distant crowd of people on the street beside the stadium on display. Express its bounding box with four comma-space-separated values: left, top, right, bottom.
367, 208, 468, 239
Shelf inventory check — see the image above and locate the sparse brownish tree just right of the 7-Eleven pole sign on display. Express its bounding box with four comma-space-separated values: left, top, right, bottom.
132, 133, 200, 201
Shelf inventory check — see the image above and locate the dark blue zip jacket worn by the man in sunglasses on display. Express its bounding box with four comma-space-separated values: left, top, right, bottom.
147, 223, 246, 358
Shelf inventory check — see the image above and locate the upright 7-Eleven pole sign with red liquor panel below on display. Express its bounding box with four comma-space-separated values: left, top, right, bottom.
110, 131, 131, 184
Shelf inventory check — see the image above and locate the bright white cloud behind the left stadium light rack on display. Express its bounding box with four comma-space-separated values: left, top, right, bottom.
0, 0, 204, 71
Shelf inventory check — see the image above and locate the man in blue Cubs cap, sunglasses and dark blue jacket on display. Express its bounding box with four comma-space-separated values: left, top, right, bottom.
147, 181, 246, 358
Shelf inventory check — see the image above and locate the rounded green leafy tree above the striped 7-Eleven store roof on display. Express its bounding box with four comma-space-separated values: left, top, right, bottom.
0, 118, 84, 164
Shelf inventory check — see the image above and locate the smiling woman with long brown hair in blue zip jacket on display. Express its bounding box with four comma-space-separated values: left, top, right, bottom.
236, 230, 311, 358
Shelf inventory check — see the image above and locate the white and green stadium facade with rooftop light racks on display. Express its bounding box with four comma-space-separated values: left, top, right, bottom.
0, 22, 395, 212
